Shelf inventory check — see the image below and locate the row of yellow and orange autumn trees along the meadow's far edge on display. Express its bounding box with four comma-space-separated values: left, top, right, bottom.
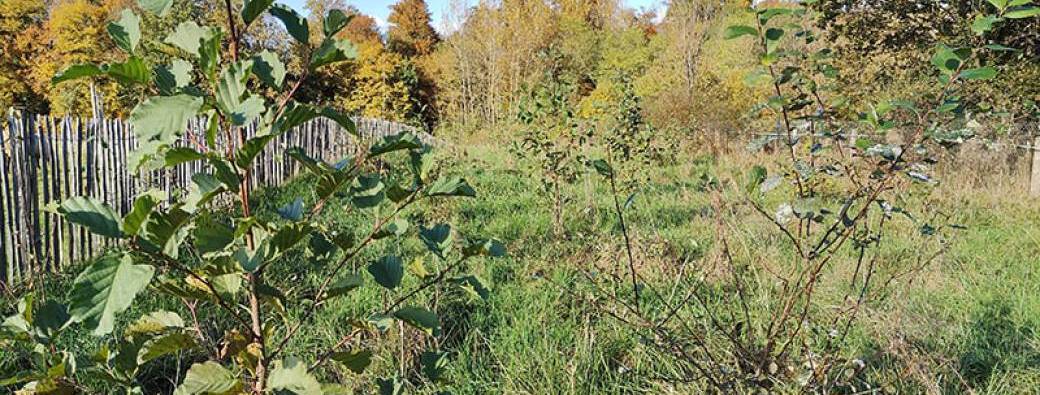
0, 0, 1040, 137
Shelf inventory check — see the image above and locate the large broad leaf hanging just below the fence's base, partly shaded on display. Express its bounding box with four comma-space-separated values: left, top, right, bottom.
69, 256, 155, 336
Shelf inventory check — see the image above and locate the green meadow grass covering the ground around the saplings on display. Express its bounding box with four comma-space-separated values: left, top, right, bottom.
0, 142, 1040, 394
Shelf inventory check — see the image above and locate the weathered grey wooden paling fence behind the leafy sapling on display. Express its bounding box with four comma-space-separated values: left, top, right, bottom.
0, 112, 433, 287
